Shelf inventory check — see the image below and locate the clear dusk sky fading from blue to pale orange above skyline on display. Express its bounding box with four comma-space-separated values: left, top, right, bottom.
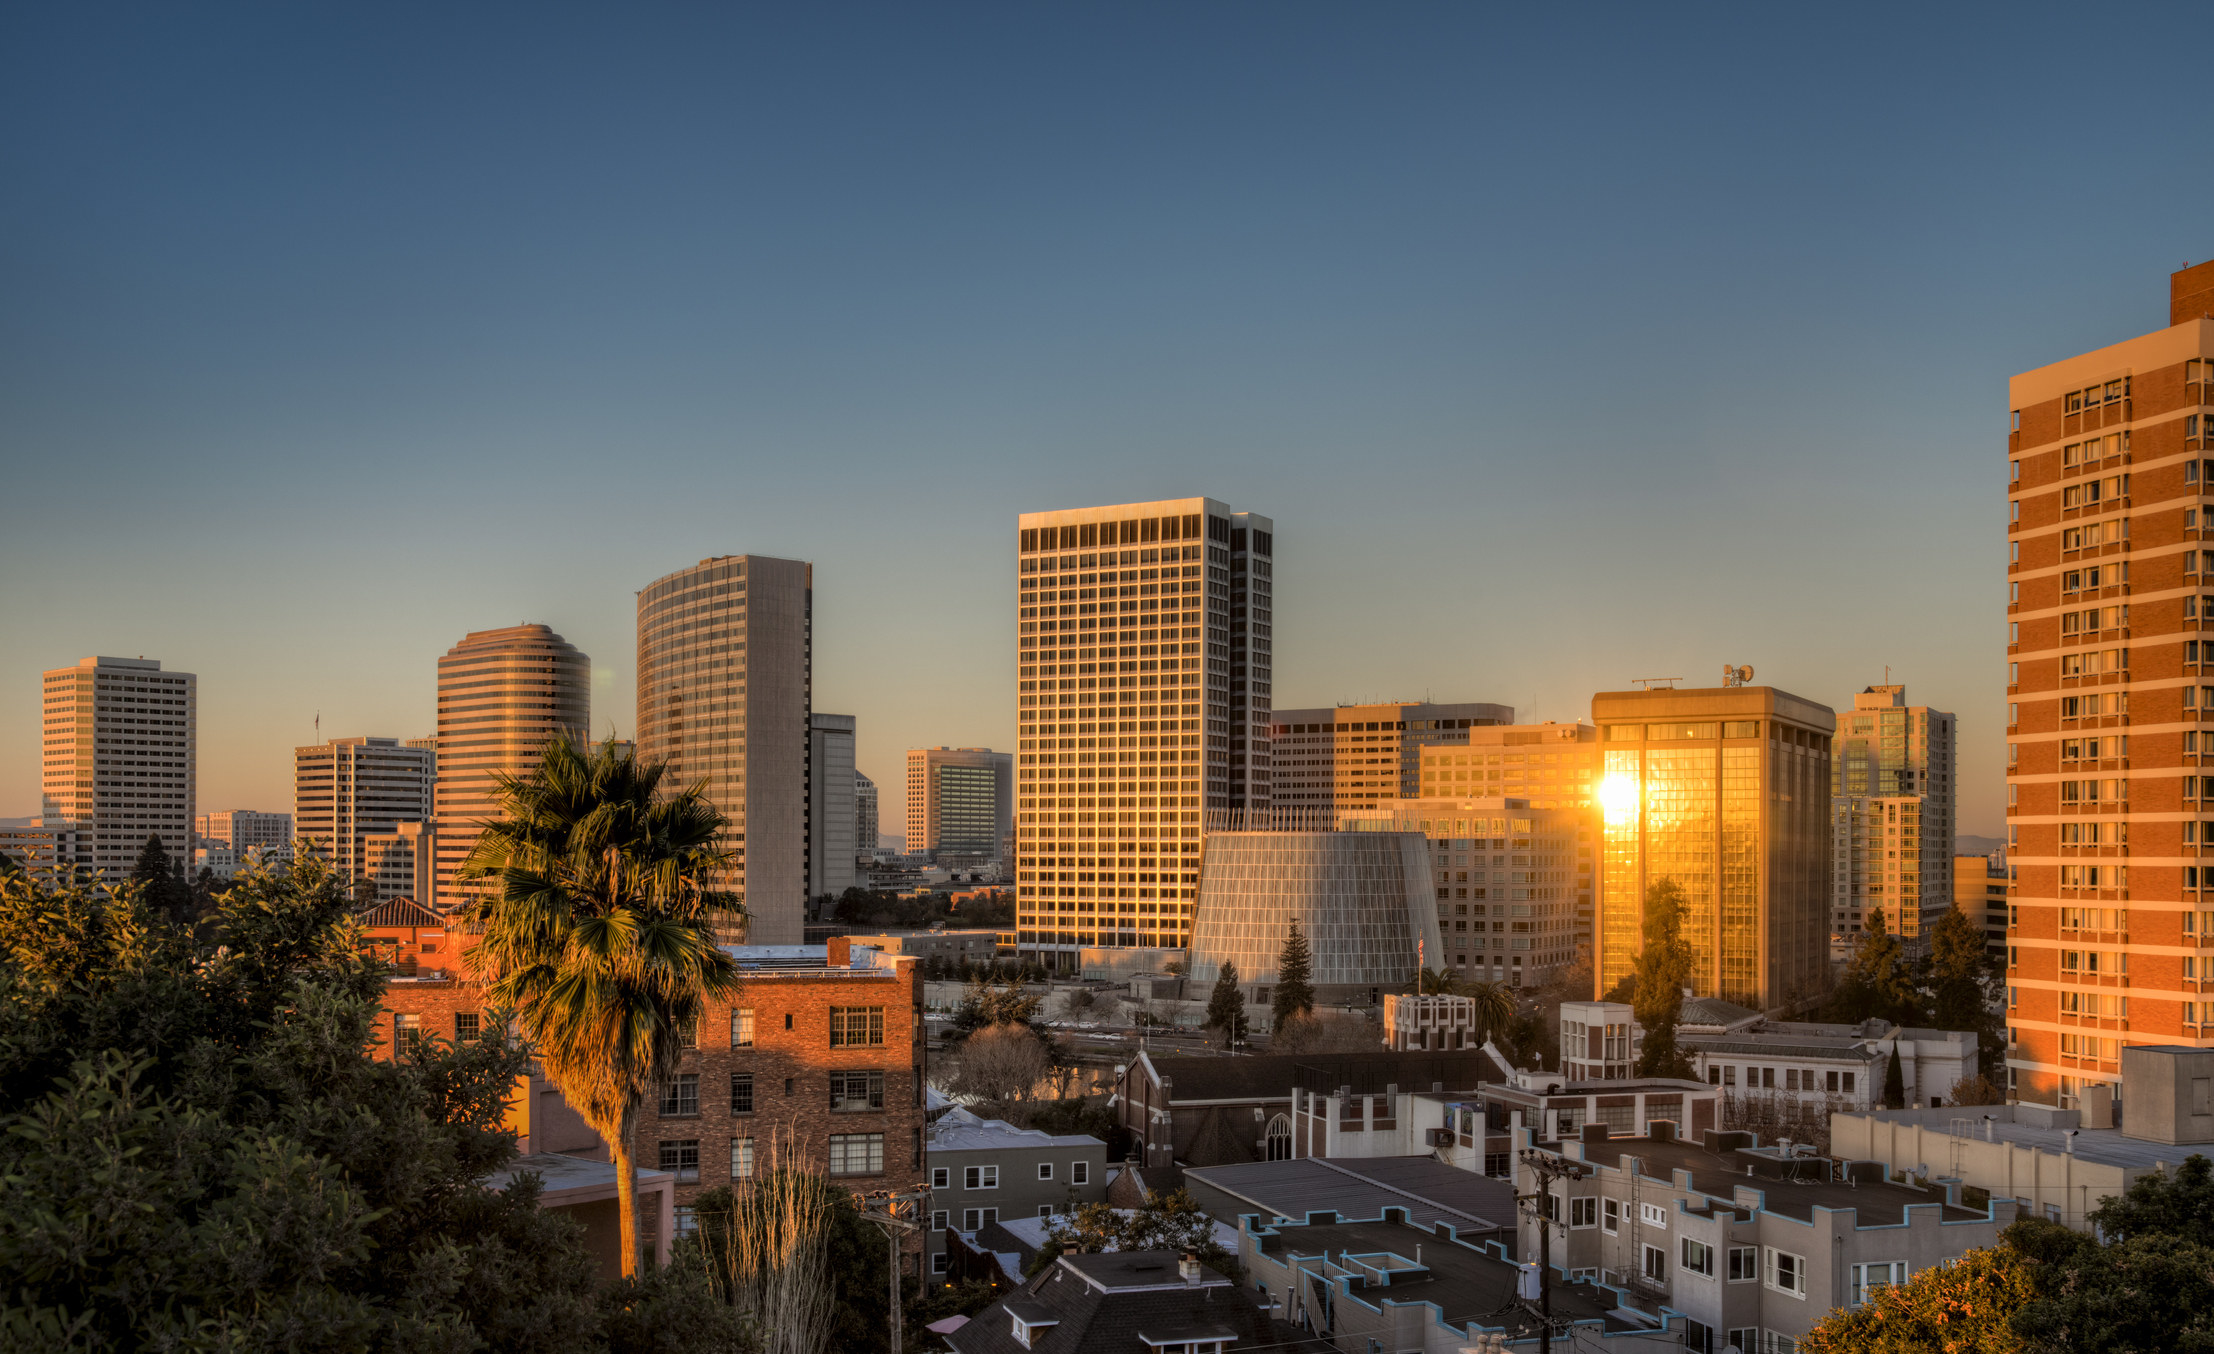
0, 4, 2214, 832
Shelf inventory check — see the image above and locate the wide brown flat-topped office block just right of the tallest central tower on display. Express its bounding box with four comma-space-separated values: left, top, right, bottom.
1269, 701, 1514, 821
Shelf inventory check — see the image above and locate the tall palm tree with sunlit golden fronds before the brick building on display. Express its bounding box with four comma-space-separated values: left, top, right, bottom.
461, 737, 744, 1274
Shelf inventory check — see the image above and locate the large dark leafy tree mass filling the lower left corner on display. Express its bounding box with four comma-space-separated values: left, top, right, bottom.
0, 858, 655, 1352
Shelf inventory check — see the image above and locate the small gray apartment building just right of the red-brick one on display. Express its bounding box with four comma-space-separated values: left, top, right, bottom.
923, 1108, 1107, 1274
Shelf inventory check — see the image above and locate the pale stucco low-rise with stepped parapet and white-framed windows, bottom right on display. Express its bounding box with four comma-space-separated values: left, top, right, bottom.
1514, 1124, 2017, 1354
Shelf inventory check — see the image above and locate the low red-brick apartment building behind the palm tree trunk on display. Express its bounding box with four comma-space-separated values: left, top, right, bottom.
376, 936, 925, 1230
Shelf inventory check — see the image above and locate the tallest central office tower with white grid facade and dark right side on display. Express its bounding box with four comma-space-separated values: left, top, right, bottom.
1014, 498, 1275, 967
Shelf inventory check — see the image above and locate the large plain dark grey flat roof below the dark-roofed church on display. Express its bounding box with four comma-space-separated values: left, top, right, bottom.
1184, 1157, 1514, 1232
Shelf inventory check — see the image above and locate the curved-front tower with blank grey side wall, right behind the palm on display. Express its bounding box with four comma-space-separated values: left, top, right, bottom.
638, 555, 815, 945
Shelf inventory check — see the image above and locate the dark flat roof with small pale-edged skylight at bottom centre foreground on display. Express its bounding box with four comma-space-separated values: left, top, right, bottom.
1255, 1221, 1649, 1343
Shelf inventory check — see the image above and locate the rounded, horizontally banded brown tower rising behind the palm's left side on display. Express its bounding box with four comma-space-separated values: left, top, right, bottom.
429, 626, 591, 907
